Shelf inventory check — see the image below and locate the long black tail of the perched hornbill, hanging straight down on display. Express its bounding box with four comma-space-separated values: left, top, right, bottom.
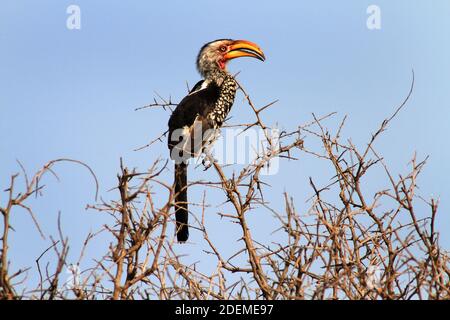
175, 162, 189, 242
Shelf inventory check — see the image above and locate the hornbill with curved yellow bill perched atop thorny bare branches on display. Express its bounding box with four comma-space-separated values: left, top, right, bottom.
168, 39, 265, 242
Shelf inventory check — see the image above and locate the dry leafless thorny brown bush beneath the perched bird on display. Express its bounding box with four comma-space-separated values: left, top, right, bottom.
0, 73, 450, 300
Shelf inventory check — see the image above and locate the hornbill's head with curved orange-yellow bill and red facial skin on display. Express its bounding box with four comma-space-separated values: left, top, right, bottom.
197, 39, 265, 78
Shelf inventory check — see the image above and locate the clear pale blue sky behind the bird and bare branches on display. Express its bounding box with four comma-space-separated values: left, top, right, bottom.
0, 0, 450, 290
